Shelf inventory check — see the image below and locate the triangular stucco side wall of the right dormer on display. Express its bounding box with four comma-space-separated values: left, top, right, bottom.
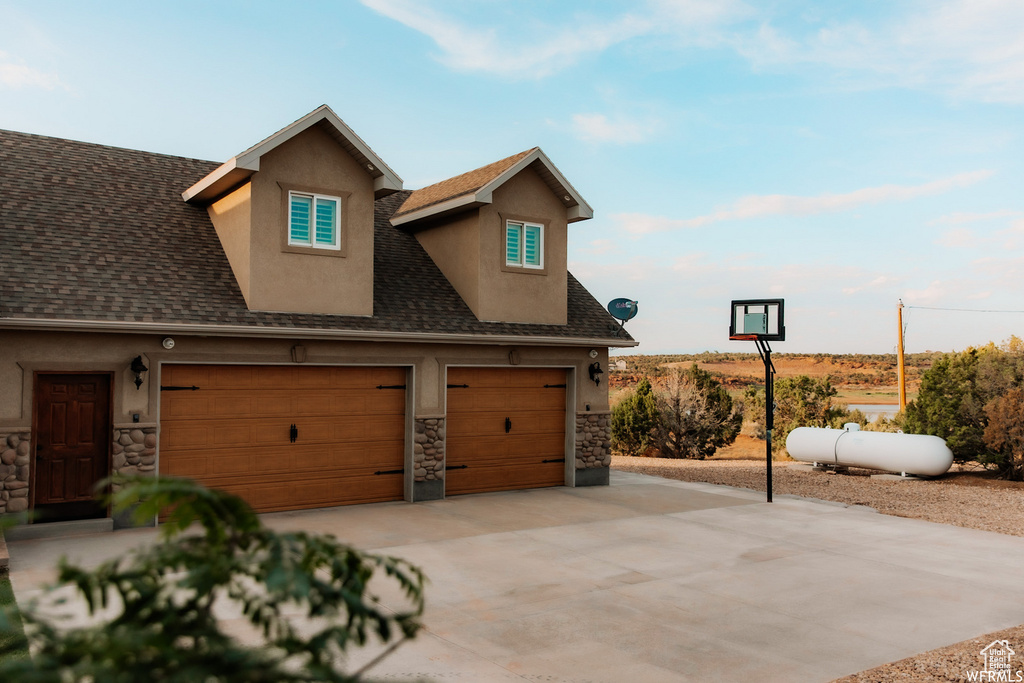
416, 211, 481, 317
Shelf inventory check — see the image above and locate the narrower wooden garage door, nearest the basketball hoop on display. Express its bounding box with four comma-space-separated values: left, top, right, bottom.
444, 368, 566, 496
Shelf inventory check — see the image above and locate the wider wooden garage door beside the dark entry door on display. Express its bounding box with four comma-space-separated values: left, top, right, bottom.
160, 366, 406, 512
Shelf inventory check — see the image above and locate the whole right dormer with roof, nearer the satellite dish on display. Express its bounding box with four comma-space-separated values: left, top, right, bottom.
391, 147, 594, 325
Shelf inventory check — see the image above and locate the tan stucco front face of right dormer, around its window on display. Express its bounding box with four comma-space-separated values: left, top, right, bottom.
474, 168, 567, 325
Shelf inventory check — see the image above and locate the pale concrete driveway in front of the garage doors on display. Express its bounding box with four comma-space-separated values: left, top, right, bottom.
8, 472, 1024, 683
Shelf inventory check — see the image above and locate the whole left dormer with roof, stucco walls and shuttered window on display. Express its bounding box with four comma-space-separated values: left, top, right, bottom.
181, 104, 401, 315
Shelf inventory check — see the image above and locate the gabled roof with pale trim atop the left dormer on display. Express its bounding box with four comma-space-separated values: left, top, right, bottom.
181, 104, 401, 206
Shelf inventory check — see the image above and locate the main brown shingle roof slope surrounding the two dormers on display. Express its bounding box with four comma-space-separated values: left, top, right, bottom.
0, 131, 632, 343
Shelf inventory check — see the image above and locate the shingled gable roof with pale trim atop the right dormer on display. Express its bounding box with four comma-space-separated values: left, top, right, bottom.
391, 147, 594, 227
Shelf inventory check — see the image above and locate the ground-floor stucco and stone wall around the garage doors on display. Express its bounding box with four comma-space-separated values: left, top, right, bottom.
0, 331, 608, 510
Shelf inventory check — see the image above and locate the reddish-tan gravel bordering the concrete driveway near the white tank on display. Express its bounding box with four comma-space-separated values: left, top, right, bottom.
611, 456, 1024, 683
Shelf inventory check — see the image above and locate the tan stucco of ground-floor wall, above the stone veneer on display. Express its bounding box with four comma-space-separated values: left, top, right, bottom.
0, 331, 608, 427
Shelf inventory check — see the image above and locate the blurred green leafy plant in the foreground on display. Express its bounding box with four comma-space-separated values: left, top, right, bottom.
0, 477, 424, 683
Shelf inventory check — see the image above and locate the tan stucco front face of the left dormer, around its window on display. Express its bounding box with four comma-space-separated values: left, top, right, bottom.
248, 127, 374, 315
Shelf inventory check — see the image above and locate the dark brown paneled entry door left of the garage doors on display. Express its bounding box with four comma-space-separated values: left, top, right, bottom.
33, 374, 112, 521
